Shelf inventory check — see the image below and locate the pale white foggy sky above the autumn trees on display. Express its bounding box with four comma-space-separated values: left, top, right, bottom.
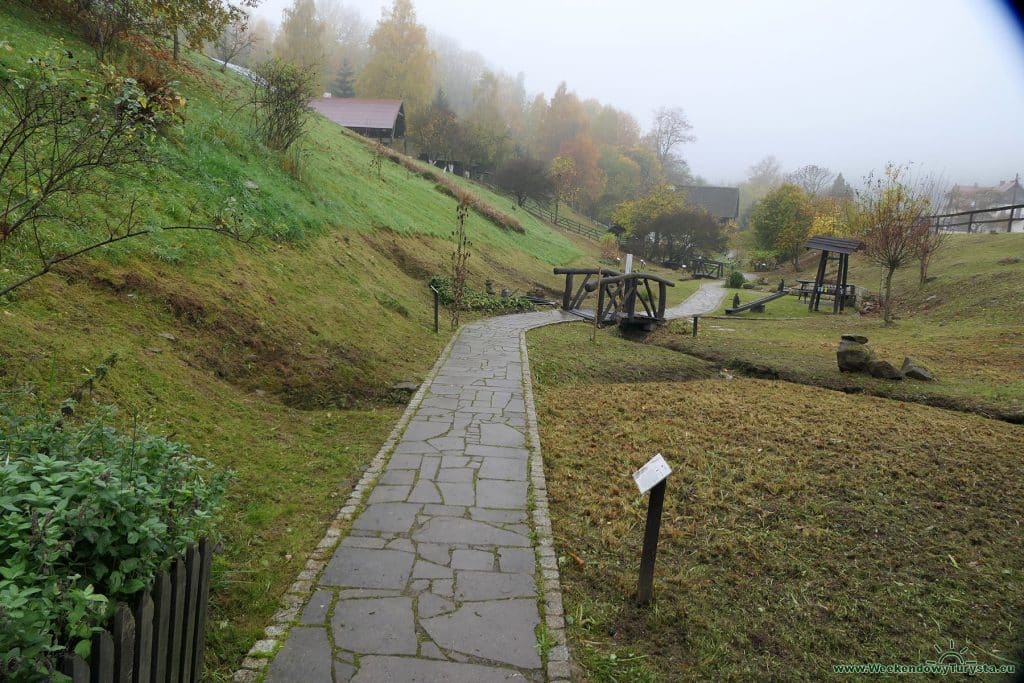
249, 0, 1024, 184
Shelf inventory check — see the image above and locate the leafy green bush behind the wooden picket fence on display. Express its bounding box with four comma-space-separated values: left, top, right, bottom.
0, 402, 228, 681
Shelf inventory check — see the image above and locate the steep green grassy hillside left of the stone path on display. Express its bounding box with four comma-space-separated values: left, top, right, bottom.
0, 3, 594, 680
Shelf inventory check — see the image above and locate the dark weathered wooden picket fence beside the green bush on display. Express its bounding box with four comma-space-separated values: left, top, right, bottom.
62, 540, 214, 683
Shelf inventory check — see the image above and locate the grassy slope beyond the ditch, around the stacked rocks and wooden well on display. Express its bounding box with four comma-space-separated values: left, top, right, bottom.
650, 233, 1024, 421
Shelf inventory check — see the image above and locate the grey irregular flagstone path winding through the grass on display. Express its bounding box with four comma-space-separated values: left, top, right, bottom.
245, 283, 724, 683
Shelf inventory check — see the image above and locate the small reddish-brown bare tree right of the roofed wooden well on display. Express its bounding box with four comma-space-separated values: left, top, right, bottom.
857, 164, 930, 325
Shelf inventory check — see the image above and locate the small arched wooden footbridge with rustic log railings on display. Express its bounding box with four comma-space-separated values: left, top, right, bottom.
555, 268, 676, 331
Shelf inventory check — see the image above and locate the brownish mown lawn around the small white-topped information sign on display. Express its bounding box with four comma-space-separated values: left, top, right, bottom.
528, 326, 1024, 681
